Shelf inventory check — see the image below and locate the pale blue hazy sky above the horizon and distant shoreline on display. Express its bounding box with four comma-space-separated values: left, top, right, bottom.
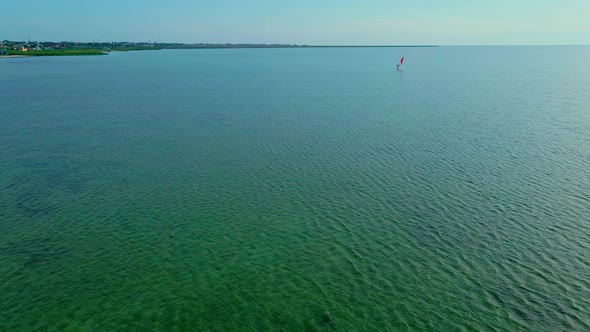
0, 0, 590, 45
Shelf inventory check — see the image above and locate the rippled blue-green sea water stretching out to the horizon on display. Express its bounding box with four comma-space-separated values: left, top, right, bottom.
0, 47, 590, 331
